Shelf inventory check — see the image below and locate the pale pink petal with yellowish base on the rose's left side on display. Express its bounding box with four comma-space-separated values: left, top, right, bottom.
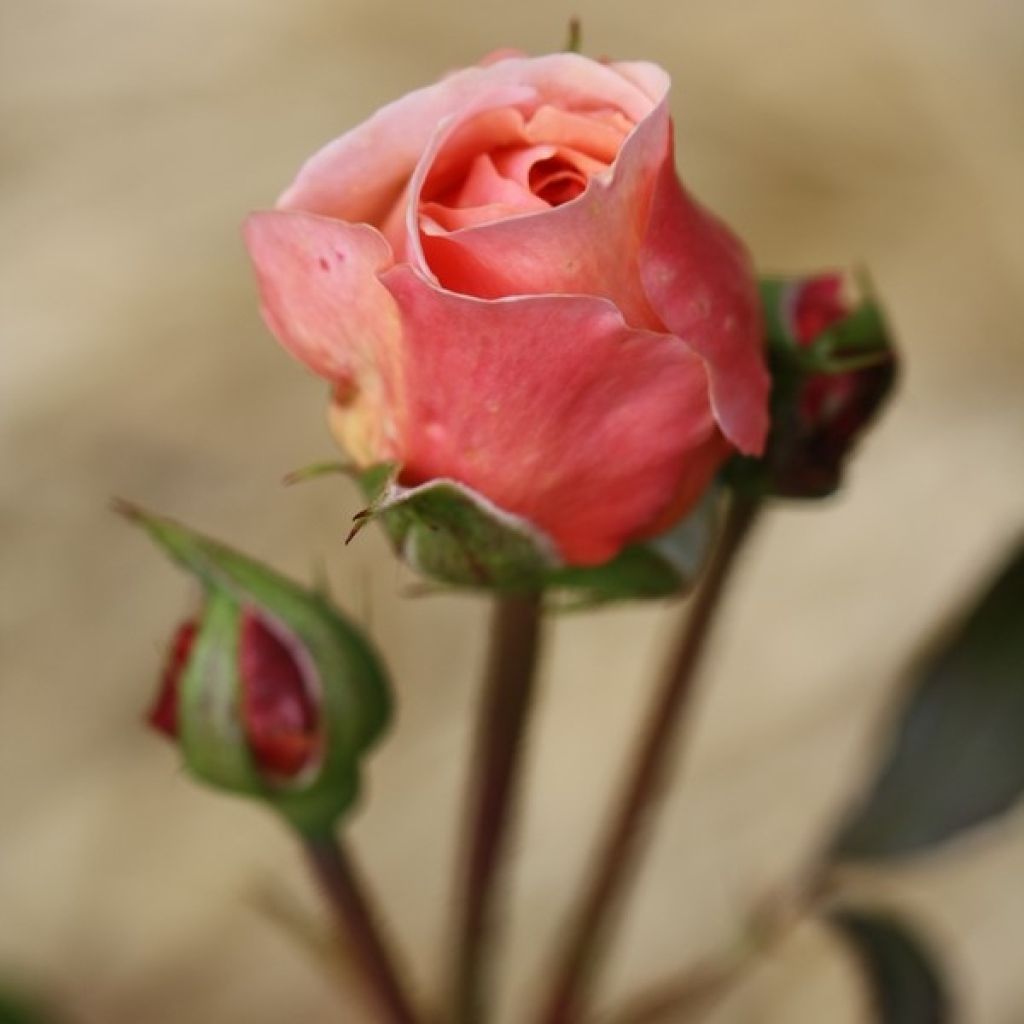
245, 212, 401, 465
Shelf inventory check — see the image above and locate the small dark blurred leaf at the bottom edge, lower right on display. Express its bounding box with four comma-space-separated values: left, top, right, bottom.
827, 908, 952, 1024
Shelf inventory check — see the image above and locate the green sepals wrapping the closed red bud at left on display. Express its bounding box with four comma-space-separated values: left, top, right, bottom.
121, 505, 391, 834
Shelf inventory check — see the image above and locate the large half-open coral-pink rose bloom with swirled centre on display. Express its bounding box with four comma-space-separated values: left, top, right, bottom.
246, 52, 768, 565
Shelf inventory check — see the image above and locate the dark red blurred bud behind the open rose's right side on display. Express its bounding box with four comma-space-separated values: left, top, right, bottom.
733, 273, 896, 498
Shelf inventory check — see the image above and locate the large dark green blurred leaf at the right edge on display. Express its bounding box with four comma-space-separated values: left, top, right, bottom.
833, 544, 1024, 860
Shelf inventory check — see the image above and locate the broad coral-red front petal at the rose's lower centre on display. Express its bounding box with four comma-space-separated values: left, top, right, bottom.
382, 266, 718, 565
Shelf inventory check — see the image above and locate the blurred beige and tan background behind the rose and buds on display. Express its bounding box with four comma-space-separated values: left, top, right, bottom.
0, 0, 1024, 1024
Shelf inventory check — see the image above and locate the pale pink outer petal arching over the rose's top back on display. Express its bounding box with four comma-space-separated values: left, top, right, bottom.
278, 53, 650, 224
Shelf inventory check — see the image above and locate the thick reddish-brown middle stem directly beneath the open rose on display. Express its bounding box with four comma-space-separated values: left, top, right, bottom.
451, 593, 542, 1024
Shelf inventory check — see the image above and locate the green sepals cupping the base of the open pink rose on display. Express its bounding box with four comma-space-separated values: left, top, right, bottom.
349, 464, 718, 607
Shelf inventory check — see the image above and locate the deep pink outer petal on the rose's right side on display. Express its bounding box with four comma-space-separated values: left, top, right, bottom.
640, 141, 770, 455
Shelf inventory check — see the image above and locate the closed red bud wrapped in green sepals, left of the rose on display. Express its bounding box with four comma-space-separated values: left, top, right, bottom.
122, 506, 390, 834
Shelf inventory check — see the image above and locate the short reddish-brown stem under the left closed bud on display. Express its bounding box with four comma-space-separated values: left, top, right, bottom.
302, 836, 421, 1024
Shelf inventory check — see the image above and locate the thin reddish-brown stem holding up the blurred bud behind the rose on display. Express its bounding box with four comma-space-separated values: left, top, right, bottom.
540, 497, 760, 1024
